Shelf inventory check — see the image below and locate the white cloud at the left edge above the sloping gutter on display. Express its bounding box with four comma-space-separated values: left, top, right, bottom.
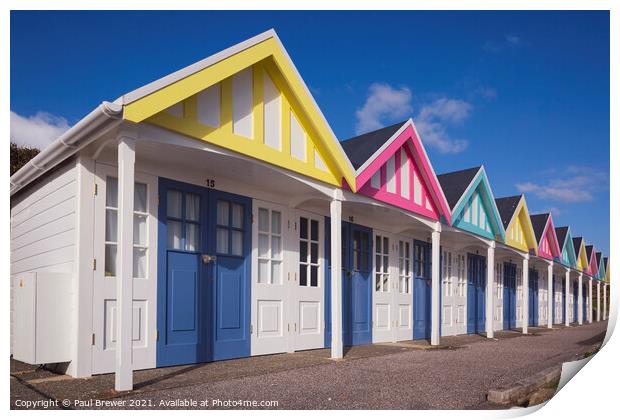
11, 111, 69, 150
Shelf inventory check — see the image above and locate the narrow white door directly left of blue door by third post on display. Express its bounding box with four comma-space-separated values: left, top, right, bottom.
393, 238, 413, 341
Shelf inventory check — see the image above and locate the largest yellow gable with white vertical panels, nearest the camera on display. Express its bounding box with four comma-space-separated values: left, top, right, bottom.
124, 34, 355, 188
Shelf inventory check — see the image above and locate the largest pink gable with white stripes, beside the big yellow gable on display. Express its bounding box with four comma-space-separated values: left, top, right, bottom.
356, 122, 451, 223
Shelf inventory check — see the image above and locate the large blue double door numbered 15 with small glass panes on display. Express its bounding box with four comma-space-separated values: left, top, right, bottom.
157, 178, 251, 366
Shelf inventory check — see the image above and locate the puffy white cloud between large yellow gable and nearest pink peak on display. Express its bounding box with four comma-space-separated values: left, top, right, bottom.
355, 83, 412, 134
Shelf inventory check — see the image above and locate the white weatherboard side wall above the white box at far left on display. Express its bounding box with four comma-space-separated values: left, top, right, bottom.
11, 160, 77, 352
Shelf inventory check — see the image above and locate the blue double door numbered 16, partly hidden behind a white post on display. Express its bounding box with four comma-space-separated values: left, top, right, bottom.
325, 218, 372, 347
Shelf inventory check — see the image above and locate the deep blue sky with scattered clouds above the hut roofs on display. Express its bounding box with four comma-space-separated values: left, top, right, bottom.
11, 11, 610, 254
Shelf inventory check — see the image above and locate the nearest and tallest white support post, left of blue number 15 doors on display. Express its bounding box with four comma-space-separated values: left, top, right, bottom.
114, 135, 136, 391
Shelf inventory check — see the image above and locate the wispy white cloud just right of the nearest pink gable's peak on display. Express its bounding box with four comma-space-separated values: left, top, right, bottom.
415, 98, 471, 153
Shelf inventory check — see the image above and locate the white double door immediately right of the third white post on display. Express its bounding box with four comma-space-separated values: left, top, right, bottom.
441, 248, 467, 336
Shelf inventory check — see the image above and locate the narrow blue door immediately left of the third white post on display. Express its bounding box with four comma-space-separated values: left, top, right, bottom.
413, 241, 431, 339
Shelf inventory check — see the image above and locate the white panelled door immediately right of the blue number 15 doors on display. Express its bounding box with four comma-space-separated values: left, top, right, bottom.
251, 200, 291, 355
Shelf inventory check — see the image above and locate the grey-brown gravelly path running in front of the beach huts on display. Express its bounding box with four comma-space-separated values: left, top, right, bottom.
11, 322, 607, 409
